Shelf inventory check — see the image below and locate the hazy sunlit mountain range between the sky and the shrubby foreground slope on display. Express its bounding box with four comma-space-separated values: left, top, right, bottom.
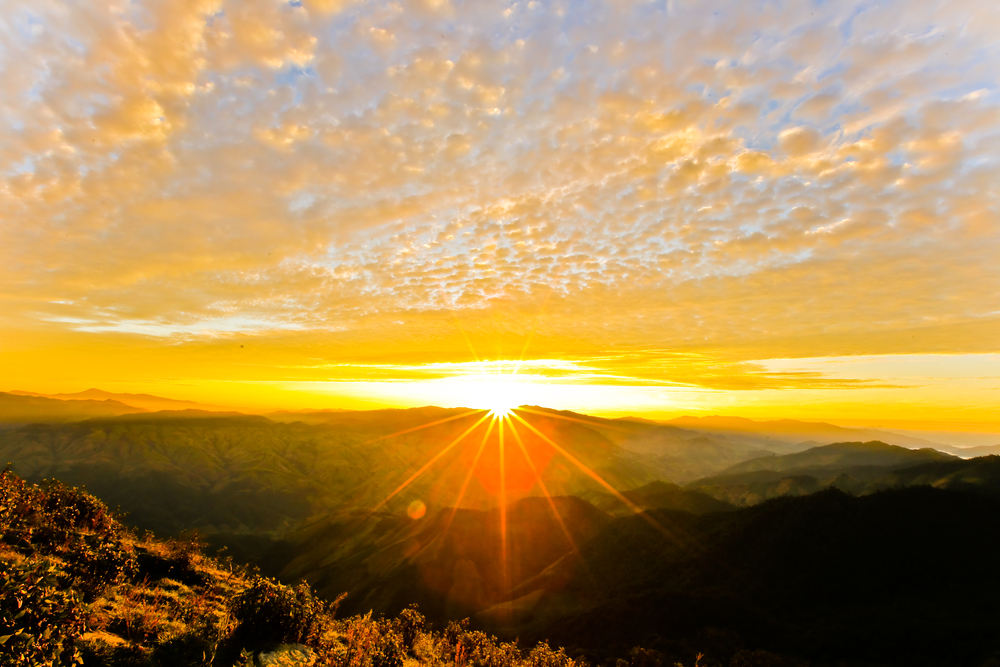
0, 392, 1000, 667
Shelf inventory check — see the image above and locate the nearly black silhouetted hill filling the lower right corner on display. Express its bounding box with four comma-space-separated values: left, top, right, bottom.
518, 487, 1000, 666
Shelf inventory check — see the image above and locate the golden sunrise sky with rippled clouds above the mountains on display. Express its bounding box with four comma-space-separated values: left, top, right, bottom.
0, 0, 1000, 431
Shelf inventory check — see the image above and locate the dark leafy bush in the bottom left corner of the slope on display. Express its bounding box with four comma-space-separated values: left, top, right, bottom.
0, 561, 85, 666
